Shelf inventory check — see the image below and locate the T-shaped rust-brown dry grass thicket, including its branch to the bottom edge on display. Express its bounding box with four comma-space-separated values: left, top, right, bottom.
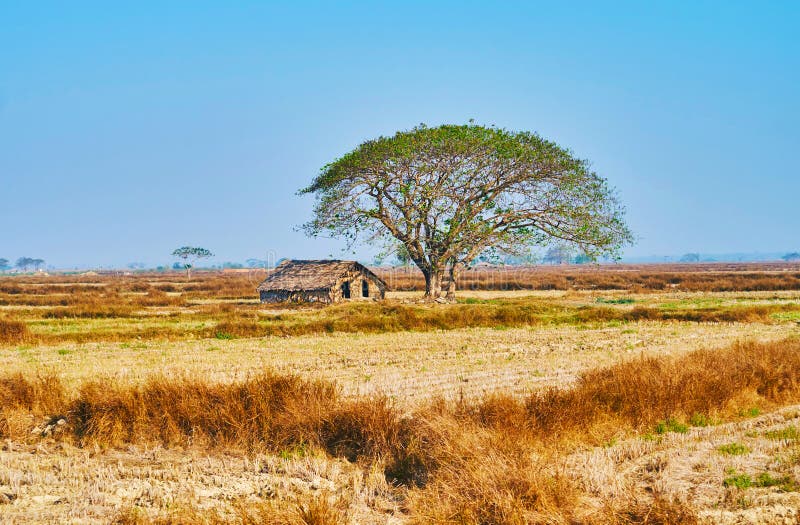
0, 340, 800, 524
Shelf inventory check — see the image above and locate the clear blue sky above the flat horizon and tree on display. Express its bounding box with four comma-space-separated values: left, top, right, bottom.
0, 0, 800, 268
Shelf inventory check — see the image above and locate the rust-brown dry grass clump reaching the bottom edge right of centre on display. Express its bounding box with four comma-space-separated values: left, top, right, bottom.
407, 417, 578, 525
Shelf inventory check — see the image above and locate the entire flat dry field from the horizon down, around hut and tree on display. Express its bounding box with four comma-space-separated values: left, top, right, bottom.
0, 264, 800, 525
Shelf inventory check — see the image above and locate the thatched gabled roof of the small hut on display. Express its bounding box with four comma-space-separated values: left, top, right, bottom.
258, 260, 386, 292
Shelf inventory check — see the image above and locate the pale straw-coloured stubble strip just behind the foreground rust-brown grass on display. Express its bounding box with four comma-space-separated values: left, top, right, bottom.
0, 322, 797, 405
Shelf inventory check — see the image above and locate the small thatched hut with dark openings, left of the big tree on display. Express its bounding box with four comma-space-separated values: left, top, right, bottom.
257, 261, 386, 303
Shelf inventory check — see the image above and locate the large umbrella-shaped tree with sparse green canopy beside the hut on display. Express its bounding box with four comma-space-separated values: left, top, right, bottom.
300, 124, 632, 299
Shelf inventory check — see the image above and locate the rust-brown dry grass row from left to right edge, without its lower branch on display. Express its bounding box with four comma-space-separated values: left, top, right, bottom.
6, 340, 800, 452
